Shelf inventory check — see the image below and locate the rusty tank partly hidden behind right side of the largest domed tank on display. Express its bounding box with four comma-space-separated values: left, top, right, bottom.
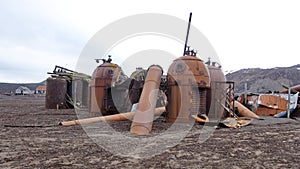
206, 65, 226, 120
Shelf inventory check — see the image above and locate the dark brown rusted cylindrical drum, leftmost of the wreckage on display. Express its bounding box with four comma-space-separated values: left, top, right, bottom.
45, 78, 67, 109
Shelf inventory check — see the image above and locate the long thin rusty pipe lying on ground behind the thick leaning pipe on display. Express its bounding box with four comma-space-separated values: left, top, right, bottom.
59, 107, 166, 126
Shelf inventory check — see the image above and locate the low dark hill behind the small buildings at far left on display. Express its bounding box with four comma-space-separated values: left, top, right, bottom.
0, 81, 46, 93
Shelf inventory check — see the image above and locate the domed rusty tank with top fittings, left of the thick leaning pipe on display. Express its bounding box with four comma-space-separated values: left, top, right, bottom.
89, 56, 126, 117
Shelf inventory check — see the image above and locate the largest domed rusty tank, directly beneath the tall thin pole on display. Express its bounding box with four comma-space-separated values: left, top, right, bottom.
166, 55, 210, 122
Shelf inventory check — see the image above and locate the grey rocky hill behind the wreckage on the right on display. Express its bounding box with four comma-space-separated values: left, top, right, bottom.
226, 64, 300, 93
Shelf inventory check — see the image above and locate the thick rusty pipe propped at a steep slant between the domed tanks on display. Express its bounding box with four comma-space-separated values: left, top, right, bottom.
130, 65, 163, 135
